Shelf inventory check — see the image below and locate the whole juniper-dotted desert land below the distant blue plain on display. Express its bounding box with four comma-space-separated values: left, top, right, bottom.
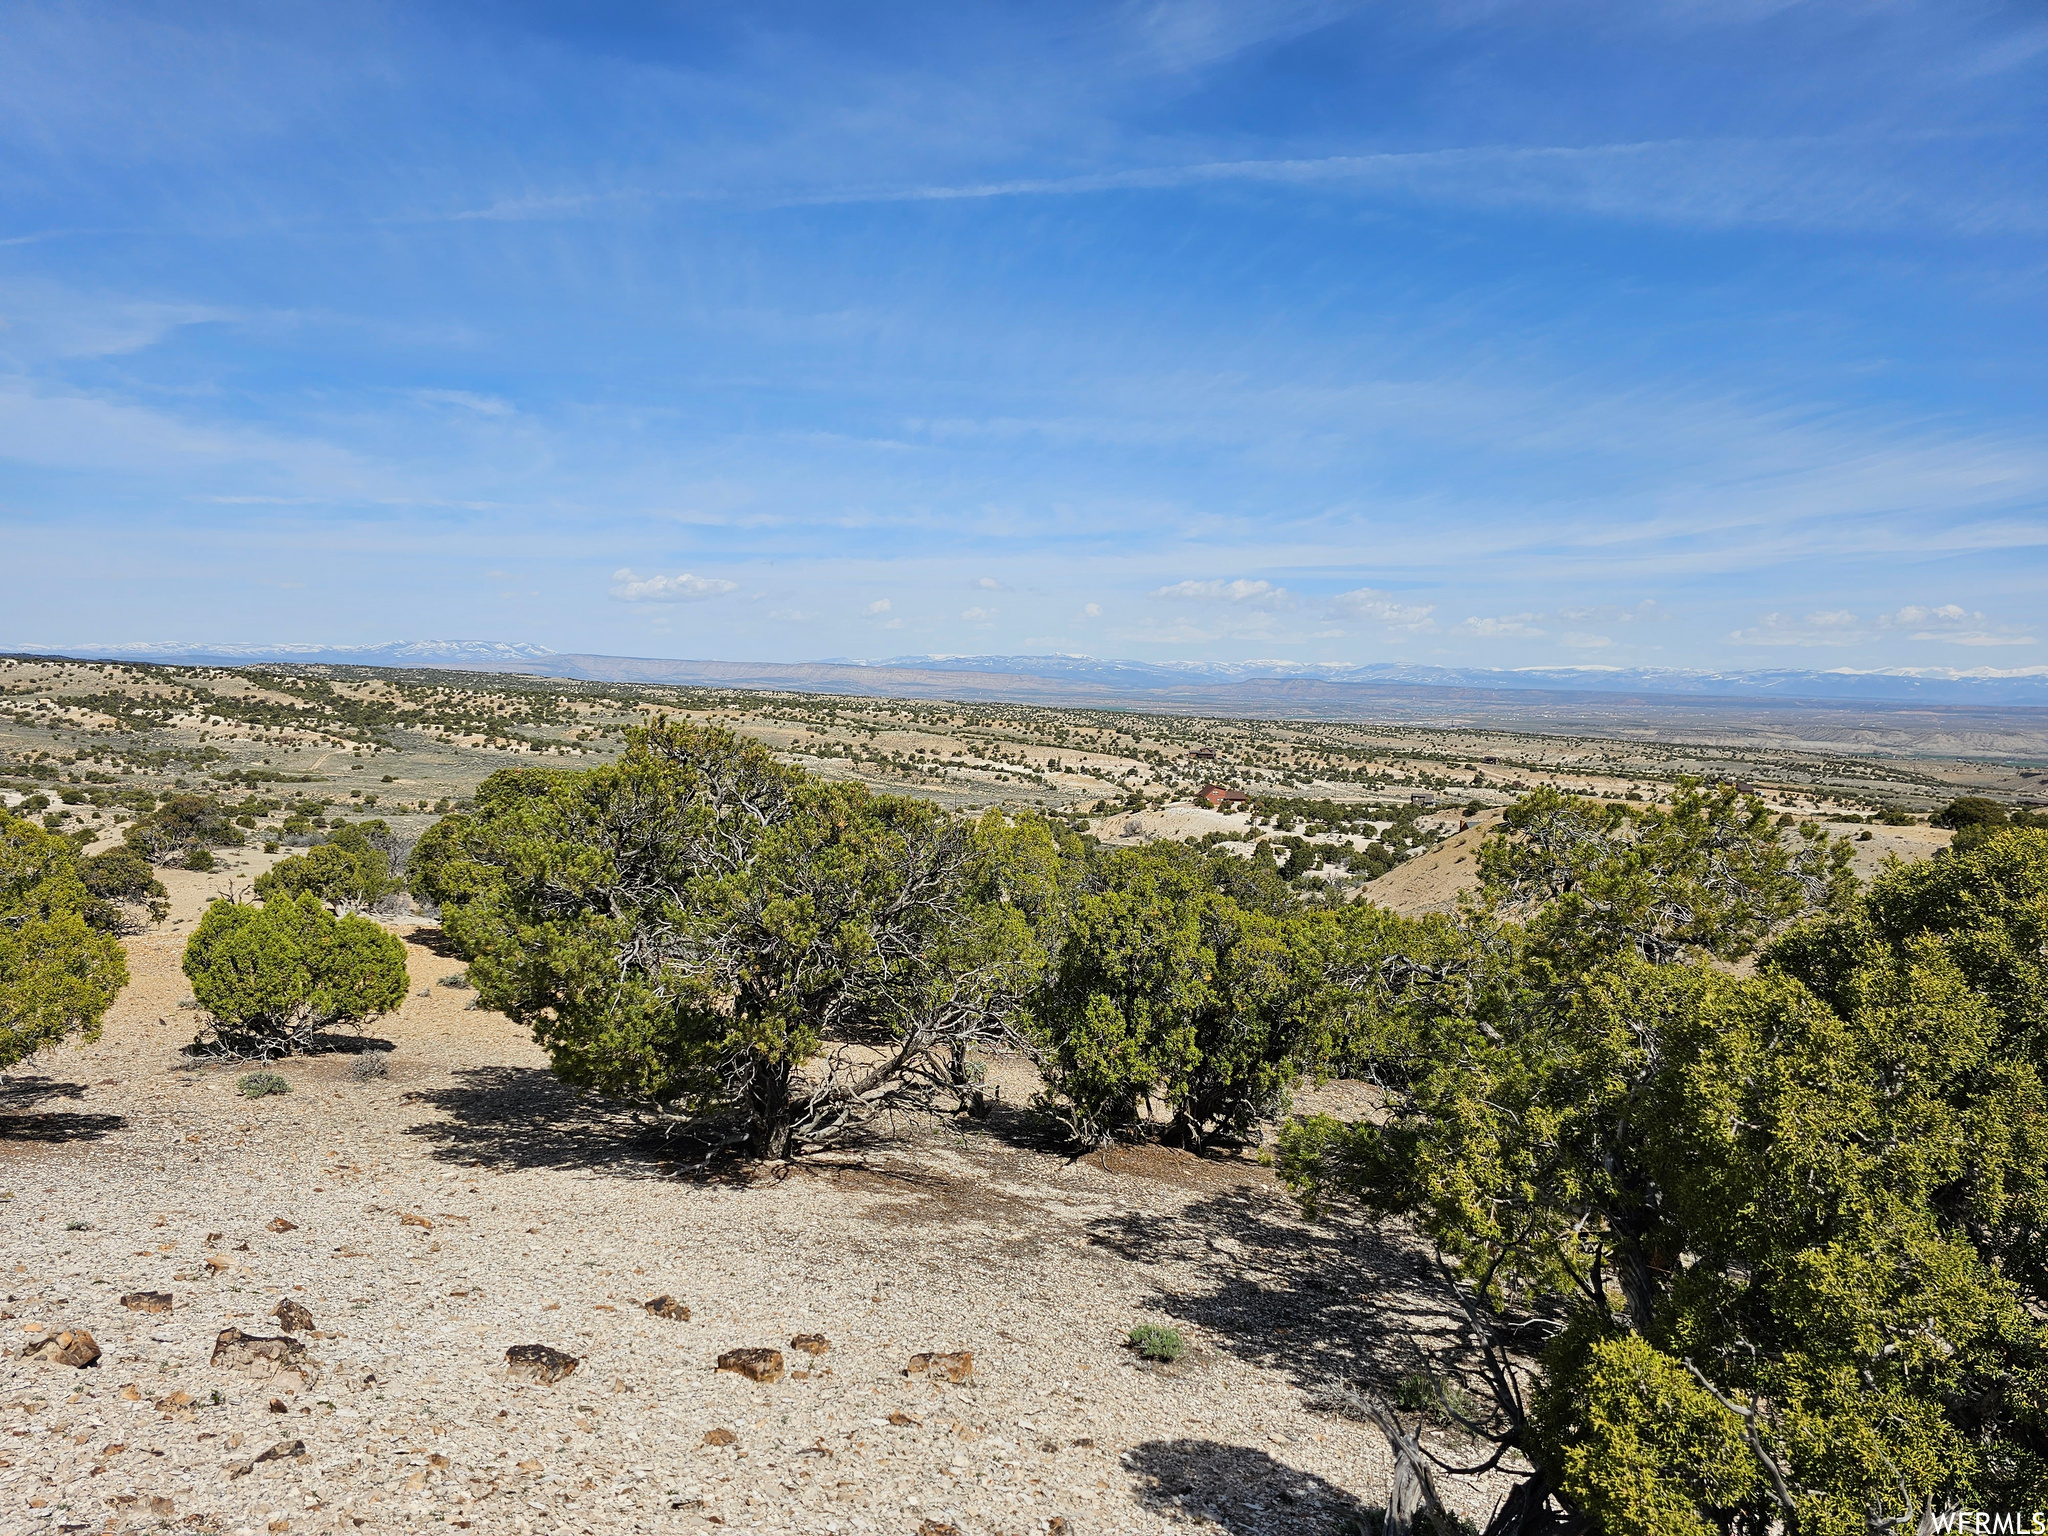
0, 664, 2048, 1534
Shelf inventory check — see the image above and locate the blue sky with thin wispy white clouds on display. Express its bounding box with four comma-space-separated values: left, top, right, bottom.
0, 0, 2048, 670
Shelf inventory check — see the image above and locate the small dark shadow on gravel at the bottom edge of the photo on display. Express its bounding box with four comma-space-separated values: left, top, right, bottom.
1126, 1440, 1380, 1536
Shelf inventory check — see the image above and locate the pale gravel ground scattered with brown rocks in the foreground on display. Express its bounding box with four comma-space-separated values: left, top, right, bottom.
0, 887, 1501, 1536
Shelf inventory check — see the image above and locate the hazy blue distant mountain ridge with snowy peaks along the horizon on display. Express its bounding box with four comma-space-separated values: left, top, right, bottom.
14, 641, 2048, 713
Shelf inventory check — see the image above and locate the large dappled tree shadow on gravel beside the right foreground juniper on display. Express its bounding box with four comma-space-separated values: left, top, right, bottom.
1087, 1186, 1470, 1399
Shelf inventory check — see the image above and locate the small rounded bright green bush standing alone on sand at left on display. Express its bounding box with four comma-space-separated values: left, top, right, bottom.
184, 895, 408, 1057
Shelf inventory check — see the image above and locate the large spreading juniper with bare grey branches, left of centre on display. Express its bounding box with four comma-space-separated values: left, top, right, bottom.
425, 721, 1057, 1157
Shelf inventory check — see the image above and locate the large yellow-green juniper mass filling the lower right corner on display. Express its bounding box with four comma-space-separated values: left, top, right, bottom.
1282, 786, 2048, 1536
